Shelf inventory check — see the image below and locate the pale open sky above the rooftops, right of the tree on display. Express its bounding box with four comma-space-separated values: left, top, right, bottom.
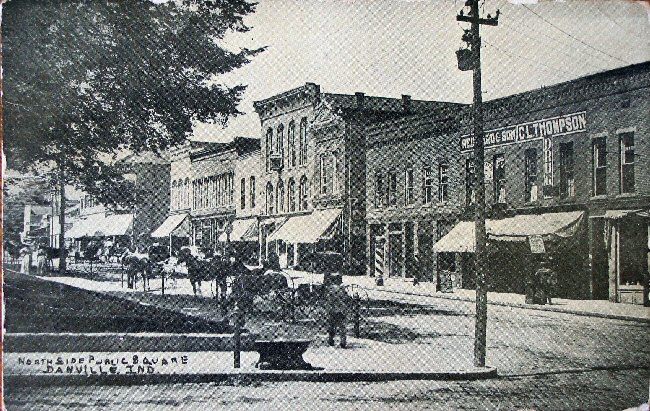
194, 0, 650, 141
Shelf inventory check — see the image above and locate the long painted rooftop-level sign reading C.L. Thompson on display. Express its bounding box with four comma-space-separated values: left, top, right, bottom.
460, 111, 587, 152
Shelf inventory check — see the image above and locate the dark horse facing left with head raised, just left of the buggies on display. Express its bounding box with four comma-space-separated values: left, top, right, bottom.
178, 248, 232, 301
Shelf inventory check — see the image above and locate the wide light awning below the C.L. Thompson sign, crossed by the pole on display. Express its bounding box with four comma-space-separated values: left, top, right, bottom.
433, 211, 583, 253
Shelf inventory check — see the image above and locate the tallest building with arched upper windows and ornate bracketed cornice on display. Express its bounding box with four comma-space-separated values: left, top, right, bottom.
255, 83, 456, 274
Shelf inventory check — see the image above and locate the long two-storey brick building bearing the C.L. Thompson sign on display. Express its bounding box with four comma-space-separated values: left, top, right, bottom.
367, 63, 650, 303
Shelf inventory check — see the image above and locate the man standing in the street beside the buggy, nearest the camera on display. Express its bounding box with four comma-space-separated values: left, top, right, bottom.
326, 274, 353, 348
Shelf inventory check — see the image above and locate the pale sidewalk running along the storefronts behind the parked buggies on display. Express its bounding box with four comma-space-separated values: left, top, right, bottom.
286, 270, 650, 323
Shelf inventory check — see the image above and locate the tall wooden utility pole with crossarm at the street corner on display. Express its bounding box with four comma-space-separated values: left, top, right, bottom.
456, 0, 500, 367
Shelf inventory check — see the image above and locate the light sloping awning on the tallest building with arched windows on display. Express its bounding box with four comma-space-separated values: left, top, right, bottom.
267, 208, 341, 244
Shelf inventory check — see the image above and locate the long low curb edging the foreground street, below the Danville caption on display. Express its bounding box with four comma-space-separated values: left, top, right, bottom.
4, 367, 498, 387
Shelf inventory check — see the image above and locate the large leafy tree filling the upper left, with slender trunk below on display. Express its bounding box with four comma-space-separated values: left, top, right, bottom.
3, 0, 263, 269
